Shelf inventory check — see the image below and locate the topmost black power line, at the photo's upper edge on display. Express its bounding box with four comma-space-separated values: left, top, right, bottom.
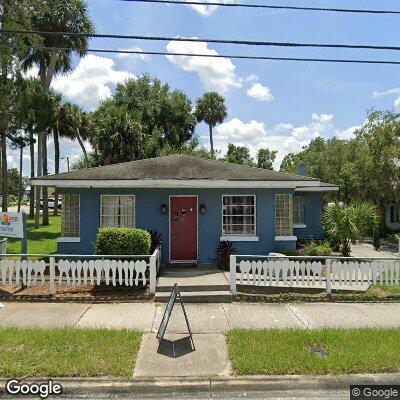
108, 0, 400, 14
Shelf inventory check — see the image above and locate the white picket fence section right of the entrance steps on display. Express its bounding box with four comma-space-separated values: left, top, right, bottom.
230, 255, 400, 295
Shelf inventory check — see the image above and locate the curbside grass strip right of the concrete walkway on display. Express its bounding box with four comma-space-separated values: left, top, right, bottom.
227, 328, 400, 375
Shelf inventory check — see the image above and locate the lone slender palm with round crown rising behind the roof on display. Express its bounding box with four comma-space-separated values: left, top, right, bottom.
195, 92, 228, 157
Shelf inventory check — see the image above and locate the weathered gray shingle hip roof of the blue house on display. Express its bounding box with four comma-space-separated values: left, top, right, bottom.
32, 155, 324, 181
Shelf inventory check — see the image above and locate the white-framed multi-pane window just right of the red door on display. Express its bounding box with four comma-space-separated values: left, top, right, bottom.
222, 196, 256, 235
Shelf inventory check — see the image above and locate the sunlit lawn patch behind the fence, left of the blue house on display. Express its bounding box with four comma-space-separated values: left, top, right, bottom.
7, 216, 61, 254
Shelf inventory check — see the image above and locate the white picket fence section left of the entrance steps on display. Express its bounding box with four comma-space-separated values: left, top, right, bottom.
0, 248, 161, 295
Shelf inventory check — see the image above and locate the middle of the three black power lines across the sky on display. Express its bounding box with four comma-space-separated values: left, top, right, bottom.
0, 29, 400, 51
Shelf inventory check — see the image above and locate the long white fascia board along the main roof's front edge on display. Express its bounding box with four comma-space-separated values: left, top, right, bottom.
31, 179, 320, 189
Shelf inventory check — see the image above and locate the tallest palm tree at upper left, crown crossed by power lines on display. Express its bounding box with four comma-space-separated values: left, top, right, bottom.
24, 0, 94, 227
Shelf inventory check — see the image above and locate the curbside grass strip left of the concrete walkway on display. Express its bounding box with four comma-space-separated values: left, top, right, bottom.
0, 328, 142, 378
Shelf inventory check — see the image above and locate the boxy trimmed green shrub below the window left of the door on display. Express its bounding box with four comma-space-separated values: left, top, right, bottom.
95, 228, 151, 255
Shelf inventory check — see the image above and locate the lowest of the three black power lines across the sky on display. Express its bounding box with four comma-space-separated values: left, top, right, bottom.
0, 45, 400, 65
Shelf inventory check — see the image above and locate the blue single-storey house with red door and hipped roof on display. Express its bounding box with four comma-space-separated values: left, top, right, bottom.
32, 155, 338, 263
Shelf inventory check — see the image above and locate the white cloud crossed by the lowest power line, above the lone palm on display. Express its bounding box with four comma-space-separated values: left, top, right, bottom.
166, 37, 242, 92
